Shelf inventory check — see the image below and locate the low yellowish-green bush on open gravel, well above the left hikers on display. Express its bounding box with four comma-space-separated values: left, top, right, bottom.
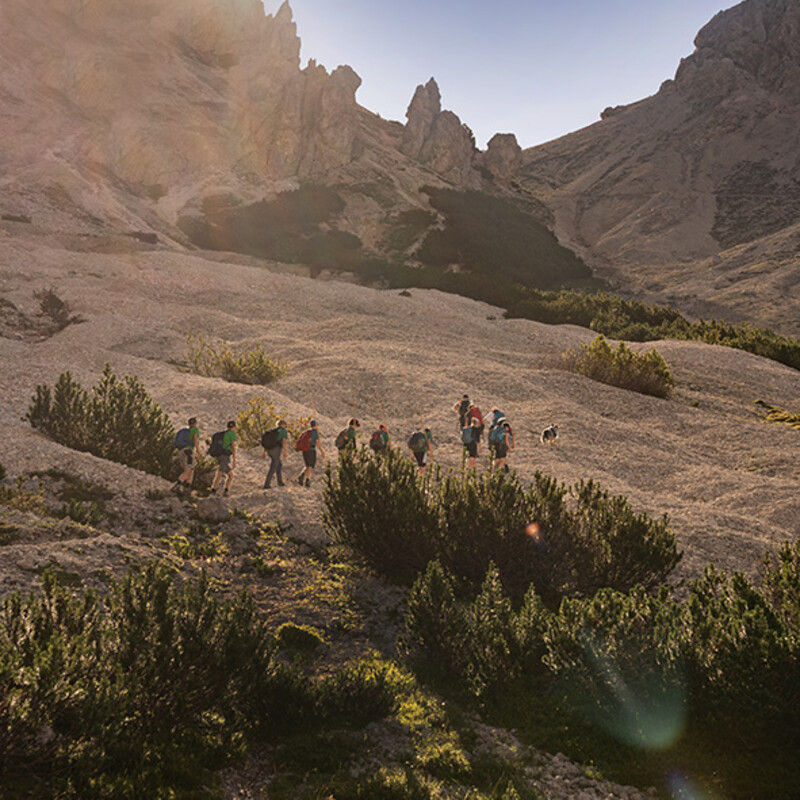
186, 333, 287, 385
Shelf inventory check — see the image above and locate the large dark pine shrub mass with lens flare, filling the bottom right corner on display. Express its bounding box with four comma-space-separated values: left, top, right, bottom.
401, 543, 800, 800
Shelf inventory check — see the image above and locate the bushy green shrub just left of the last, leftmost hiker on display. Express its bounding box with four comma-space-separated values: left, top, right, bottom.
26, 364, 175, 477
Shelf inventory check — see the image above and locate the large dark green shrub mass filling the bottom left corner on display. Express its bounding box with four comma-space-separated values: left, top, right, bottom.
0, 565, 398, 800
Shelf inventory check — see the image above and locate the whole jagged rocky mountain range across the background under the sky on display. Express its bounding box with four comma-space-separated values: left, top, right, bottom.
0, 0, 800, 335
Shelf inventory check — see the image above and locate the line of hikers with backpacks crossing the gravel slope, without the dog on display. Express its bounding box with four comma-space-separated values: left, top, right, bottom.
173, 394, 514, 496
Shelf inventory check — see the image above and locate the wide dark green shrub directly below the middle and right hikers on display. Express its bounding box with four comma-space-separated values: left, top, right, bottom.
323, 449, 680, 605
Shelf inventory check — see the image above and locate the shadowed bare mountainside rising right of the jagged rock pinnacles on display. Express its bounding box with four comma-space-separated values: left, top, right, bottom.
516, 0, 800, 334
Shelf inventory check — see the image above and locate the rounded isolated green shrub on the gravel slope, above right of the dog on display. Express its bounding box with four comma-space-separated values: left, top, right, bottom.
564, 335, 675, 397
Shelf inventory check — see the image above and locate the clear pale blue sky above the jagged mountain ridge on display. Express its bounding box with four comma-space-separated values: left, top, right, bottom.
264, 0, 735, 149
